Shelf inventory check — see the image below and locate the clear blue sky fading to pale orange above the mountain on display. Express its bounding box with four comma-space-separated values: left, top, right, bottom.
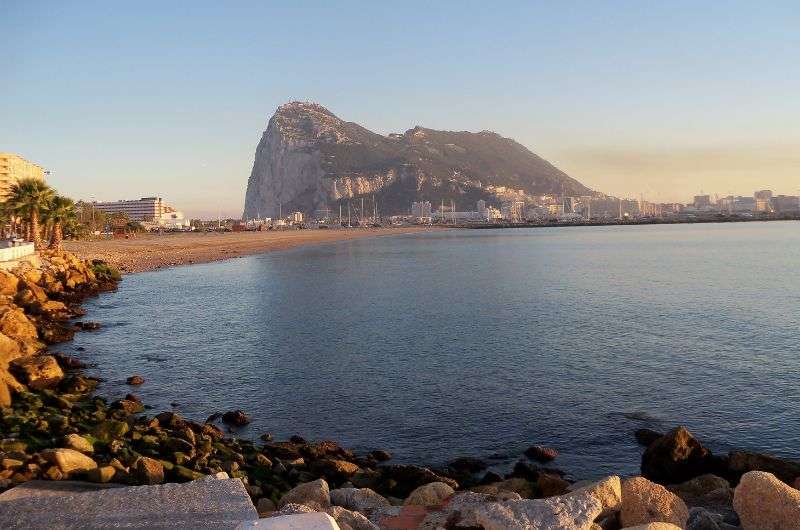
0, 0, 800, 217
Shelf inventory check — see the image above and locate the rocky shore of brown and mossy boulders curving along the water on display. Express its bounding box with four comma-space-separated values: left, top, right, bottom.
0, 253, 800, 530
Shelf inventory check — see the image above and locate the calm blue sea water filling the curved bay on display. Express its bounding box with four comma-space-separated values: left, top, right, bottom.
70, 222, 800, 477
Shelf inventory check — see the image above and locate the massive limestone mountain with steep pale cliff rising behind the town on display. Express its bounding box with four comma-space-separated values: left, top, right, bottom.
244, 102, 591, 219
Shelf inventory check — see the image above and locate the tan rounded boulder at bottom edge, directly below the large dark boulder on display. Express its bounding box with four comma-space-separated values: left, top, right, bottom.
620, 477, 689, 528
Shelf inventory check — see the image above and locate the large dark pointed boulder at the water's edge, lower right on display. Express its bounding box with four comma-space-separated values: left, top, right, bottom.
642, 427, 713, 484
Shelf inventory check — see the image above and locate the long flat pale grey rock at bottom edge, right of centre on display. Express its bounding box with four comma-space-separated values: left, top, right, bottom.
474, 488, 603, 530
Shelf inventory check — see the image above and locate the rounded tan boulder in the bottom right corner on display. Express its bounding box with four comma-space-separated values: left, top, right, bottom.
733, 471, 800, 530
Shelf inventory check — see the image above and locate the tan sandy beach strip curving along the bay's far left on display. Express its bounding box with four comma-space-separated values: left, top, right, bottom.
64, 226, 440, 273
